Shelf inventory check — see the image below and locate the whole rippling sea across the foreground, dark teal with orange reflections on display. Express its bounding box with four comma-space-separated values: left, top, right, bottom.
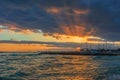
0, 53, 120, 80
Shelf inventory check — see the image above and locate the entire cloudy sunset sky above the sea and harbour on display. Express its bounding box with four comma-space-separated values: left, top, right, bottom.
0, 0, 120, 51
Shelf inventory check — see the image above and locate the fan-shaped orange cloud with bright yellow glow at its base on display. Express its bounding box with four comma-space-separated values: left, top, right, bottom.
43, 25, 95, 43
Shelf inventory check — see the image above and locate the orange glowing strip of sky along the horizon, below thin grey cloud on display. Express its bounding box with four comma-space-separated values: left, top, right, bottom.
0, 43, 74, 52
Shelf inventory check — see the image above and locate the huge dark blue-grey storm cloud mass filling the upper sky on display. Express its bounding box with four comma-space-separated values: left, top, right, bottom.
0, 0, 120, 40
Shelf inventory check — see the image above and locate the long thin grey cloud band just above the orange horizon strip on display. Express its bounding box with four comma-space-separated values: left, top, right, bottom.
0, 40, 85, 48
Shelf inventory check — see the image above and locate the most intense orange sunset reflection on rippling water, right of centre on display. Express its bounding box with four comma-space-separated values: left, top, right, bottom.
50, 56, 99, 80
